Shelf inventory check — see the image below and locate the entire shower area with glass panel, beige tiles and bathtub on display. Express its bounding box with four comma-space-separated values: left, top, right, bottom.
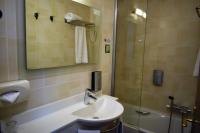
112, 0, 200, 133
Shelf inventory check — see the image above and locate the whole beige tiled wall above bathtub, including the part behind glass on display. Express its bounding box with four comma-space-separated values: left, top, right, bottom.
115, 0, 200, 112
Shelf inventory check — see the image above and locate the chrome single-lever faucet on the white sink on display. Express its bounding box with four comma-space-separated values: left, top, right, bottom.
84, 89, 97, 105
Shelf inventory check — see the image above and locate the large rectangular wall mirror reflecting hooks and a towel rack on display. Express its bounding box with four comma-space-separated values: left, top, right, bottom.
25, 0, 101, 70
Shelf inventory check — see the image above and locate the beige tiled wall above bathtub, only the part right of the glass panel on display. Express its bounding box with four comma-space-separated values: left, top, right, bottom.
142, 0, 200, 111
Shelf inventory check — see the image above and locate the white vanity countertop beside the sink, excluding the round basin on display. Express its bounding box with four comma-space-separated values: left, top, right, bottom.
13, 94, 117, 133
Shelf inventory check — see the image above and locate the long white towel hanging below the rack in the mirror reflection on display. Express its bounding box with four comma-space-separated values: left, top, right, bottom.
75, 26, 88, 64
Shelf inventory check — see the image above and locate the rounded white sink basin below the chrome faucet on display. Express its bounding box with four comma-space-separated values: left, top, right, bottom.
72, 97, 124, 122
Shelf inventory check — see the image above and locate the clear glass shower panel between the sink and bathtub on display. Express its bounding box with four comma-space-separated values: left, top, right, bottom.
115, 0, 147, 130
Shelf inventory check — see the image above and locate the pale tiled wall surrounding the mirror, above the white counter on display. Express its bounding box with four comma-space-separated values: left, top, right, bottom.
0, 0, 114, 118
